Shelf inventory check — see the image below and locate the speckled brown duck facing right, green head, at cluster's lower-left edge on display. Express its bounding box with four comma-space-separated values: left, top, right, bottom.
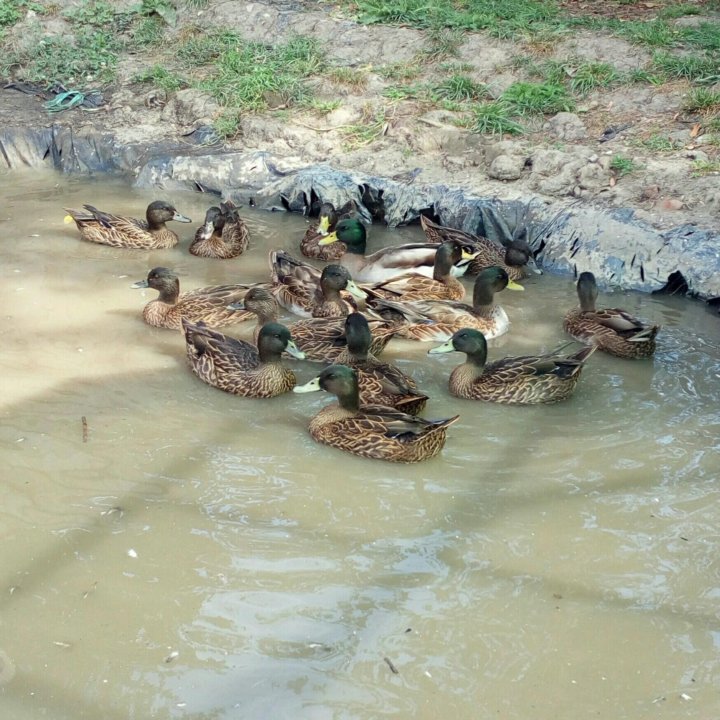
182, 318, 305, 398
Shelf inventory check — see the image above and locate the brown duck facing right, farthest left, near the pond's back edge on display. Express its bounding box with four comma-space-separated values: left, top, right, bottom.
65, 200, 192, 250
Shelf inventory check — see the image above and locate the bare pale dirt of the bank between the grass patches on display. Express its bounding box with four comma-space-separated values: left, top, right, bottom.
0, 0, 720, 235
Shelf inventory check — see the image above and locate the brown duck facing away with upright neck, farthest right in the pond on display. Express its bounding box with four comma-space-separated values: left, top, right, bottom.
563, 272, 660, 359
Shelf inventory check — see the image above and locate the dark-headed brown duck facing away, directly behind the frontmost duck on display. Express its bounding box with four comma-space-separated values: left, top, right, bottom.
335, 313, 428, 415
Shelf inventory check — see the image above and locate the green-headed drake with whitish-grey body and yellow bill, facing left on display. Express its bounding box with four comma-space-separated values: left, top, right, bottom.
318, 218, 466, 283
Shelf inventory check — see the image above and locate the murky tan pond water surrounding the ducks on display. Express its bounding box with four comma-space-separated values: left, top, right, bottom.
0, 173, 720, 720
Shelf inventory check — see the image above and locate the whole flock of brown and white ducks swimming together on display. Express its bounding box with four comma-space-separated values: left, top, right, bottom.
66, 201, 659, 463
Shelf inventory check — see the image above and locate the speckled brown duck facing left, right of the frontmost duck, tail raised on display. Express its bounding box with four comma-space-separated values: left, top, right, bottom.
428, 328, 595, 405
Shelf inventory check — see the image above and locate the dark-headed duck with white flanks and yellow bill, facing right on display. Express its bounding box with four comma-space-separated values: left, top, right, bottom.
371, 267, 522, 342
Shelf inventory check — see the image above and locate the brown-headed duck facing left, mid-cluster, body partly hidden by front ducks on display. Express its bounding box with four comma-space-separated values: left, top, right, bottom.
231, 286, 399, 364
